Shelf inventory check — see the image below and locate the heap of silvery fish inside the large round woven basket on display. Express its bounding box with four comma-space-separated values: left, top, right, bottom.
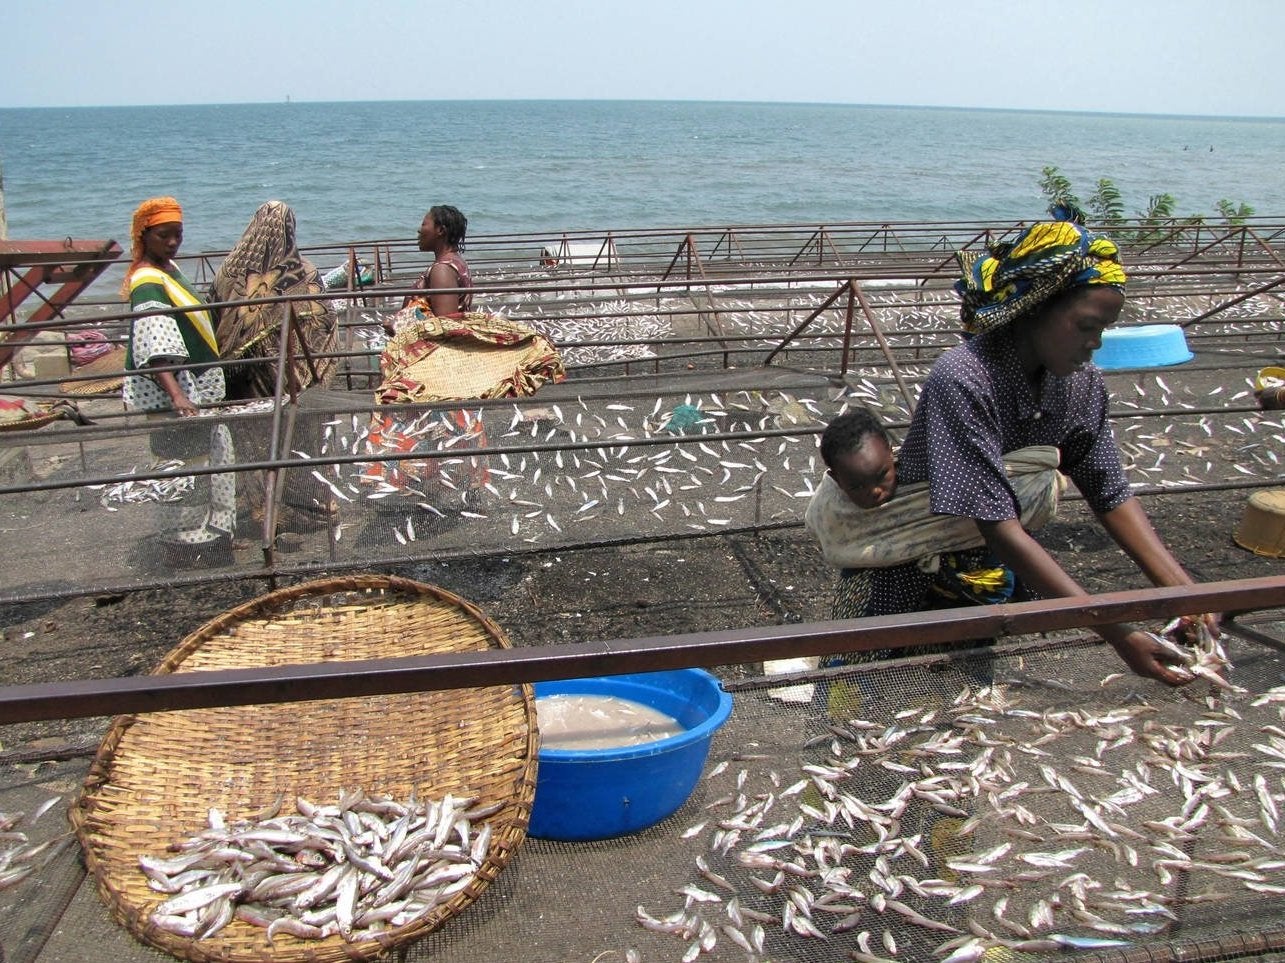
139, 789, 504, 942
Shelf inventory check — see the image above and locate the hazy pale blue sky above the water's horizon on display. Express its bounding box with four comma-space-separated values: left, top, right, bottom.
0, 0, 1285, 117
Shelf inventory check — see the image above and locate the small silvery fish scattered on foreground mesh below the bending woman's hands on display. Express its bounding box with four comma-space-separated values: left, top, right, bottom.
636, 657, 1285, 963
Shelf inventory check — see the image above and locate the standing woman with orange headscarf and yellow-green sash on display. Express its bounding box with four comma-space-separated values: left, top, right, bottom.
122, 197, 236, 564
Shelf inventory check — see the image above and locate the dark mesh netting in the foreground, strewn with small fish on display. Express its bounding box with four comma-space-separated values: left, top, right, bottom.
0, 626, 1285, 963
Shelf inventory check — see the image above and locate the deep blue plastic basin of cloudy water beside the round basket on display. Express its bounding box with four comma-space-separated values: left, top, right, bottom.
527, 669, 731, 840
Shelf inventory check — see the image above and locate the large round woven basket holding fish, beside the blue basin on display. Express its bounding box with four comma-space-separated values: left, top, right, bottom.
71, 576, 538, 963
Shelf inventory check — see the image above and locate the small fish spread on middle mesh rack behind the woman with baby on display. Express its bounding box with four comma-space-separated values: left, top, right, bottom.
293, 366, 1285, 560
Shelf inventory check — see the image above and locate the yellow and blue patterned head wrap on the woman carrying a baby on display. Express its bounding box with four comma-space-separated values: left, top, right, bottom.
955, 206, 1128, 334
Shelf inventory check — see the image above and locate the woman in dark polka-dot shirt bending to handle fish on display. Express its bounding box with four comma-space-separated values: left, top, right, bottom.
835, 208, 1218, 685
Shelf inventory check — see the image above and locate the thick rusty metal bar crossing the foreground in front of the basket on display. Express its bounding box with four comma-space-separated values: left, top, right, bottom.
0, 576, 1285, 724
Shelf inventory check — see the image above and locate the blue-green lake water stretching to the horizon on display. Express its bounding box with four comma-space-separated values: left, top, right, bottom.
0, 100, 1285, 253
